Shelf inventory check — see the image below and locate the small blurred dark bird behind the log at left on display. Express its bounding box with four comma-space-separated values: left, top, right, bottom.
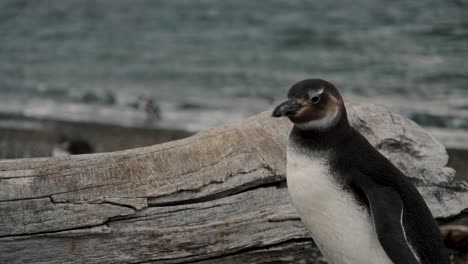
52, 136, 94, 157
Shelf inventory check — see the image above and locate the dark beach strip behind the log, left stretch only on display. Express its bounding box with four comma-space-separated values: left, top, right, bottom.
0, 121, 194, 159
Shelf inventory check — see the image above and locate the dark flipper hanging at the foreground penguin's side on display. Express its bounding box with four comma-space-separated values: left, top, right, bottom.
352, 177, 420, 264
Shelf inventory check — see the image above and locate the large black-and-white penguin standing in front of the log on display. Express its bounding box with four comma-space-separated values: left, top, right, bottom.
272, 79, 450, 264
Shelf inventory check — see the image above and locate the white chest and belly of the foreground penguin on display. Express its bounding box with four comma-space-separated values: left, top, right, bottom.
287, 147, 393, 264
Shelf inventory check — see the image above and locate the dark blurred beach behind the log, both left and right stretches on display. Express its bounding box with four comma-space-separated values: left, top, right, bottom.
0, 118, 468, 181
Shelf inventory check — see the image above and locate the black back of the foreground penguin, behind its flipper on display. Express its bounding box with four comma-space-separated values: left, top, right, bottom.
330, 129, 449, 264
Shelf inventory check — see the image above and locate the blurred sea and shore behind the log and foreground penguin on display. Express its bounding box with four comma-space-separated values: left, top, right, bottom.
0, 0, 468, 178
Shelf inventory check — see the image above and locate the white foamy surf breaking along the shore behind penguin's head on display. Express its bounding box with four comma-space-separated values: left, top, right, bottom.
0, 94, 468, 133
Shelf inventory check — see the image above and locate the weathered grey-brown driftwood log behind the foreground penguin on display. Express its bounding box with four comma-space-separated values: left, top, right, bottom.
0, 105, 468, 263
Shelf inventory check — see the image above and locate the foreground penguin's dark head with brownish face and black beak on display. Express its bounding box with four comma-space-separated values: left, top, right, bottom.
273, 79, 346, 130
